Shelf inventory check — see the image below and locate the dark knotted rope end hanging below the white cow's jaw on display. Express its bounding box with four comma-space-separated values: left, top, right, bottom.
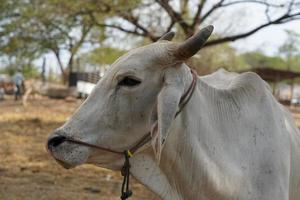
121, 150, 132, 200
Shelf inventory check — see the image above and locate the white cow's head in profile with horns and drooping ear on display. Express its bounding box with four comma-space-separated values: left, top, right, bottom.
47, 26, 213, 169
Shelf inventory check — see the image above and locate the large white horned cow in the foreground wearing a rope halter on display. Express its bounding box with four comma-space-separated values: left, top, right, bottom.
48, 26, 300, 200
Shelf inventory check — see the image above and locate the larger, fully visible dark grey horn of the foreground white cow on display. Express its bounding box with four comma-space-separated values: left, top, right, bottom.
174, 25, 214, 60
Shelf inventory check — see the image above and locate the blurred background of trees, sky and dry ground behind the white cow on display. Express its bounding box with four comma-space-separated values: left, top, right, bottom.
0, 0, 300, 200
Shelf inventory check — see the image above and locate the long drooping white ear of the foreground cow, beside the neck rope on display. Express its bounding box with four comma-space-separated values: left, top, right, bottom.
151, 65, 184, 162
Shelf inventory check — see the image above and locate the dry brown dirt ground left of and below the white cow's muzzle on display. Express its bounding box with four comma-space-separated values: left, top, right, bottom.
0, 97, 155, 200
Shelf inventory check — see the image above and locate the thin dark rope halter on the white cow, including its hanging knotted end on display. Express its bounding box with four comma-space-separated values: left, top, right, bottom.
64, 69, 197, 200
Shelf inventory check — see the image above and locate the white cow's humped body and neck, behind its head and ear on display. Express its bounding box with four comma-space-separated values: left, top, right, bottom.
132, 70, 300, 200
